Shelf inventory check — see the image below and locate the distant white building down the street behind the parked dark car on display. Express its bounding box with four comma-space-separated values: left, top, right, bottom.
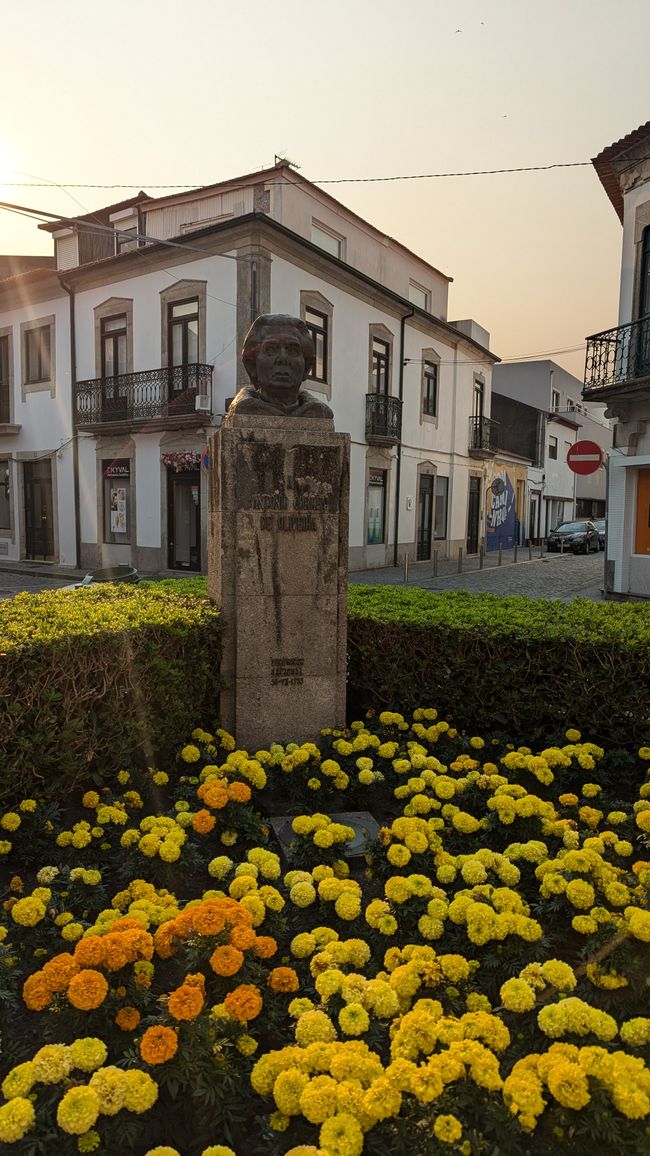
488, 361, 612, 541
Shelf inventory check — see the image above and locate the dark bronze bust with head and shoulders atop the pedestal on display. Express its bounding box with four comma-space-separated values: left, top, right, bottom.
228, 313, 333, 417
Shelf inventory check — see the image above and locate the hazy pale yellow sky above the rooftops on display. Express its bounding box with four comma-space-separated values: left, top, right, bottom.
0, 0, 650, 378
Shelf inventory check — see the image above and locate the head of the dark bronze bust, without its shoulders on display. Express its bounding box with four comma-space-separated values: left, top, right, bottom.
242, 313, 316, 406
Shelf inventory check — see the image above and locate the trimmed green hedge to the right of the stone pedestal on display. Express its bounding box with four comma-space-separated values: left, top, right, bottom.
348, 586, 650, 748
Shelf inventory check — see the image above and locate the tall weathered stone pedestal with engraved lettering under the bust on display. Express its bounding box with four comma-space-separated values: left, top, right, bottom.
208, 414, 349, 750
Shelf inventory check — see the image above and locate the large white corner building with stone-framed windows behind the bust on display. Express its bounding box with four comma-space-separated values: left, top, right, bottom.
0, 162, 496, 572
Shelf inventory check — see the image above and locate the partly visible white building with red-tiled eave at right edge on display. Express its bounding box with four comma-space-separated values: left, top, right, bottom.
583, 121, 650, 598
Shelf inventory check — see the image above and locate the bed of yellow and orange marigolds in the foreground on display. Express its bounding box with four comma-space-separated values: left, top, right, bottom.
0, 710, 650, 1156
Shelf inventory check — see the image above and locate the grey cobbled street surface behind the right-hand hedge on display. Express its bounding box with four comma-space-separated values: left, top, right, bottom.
349, 547, 605, 602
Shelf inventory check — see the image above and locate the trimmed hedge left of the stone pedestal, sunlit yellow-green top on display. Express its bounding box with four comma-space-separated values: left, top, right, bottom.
0, 585, 221, 799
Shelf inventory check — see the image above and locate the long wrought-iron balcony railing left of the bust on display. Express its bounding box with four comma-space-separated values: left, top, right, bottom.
75, 364, 213, 425
